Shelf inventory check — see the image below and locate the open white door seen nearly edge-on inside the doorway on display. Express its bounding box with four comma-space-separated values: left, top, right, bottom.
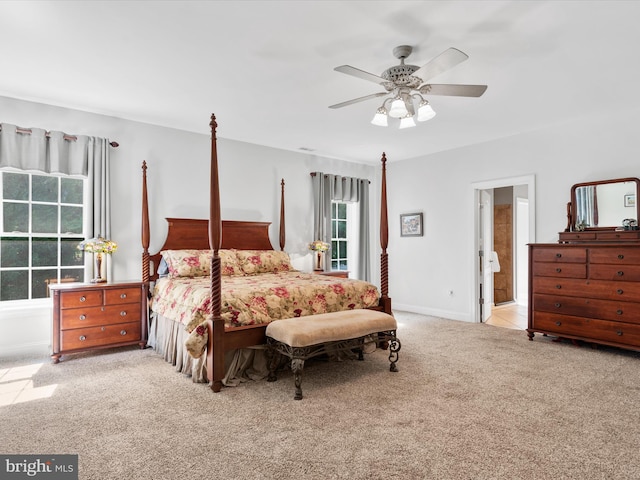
478, 190, 493, 322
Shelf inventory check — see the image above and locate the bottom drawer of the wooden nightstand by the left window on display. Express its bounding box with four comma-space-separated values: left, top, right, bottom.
60, 322, 140, 351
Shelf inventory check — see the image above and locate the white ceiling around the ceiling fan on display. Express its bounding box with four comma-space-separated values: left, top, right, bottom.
0, 0, 640, 163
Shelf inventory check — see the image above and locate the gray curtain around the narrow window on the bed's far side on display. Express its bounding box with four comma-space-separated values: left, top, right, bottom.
311, 172, 371, 281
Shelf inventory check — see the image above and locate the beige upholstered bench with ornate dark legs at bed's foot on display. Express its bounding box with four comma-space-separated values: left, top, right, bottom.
266, 309, 400, 400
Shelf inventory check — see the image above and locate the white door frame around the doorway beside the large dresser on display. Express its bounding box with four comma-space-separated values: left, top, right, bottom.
470, 174, 536, 323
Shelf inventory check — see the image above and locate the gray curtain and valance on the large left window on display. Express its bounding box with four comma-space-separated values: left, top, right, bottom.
0, 123, 112, 278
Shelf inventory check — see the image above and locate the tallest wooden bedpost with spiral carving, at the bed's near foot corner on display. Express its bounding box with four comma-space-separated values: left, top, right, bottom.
207, 114, 224, 392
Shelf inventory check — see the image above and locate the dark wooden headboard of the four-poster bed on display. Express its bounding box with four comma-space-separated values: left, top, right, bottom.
149, 218, 273, 281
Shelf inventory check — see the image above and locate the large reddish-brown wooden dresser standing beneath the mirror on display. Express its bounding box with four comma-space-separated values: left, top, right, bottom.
527, 242, 640, 350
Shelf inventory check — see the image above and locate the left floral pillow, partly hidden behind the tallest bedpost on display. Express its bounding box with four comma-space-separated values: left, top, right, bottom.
160, 250, 243, 278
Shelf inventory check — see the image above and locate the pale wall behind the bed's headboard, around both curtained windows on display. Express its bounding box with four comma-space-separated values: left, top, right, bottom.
0, 97, 380, 356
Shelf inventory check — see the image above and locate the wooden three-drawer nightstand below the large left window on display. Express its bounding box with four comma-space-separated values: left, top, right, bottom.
49, 281, 147, 363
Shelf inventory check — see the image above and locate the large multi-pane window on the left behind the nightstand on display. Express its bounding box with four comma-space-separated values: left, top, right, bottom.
0, 170, 85, 302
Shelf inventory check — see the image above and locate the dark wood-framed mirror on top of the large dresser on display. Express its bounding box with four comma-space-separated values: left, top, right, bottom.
570, 177, 640, 231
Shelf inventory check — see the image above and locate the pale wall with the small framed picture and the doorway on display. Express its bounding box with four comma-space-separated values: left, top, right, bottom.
387, 106, 640, 321
